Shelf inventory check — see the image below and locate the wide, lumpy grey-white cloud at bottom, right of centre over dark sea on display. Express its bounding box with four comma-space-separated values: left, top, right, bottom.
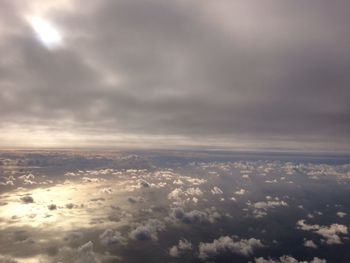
198, 236, 263, 260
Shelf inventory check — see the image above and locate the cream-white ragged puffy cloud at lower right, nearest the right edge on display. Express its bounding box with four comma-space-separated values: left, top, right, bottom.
297, 220, 348, 245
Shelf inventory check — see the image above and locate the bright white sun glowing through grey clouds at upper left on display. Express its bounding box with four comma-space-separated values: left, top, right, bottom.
29, 17, 63, 48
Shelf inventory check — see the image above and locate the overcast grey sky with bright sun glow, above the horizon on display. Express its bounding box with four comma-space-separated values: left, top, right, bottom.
0, 0, 350, 152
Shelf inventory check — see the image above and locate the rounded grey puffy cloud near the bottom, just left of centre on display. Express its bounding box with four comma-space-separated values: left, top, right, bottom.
129, 219, 165, 241
